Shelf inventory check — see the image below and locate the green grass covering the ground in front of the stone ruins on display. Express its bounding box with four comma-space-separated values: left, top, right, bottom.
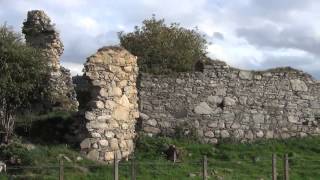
0, 112, 320, 180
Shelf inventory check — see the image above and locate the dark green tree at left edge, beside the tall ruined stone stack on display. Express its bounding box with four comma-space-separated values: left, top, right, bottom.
0, 25, 47, 143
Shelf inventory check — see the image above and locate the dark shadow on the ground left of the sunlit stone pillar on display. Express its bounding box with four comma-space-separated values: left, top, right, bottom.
15, 112, 80, 147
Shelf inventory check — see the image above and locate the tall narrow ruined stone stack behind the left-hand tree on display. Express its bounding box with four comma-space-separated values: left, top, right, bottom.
22, 10, 78, 110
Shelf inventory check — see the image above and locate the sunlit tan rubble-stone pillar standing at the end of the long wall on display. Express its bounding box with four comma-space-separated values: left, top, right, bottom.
80, 46, 139, 162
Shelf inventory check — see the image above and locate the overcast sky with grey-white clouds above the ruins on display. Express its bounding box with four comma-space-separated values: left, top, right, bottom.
0, 0, 320, 79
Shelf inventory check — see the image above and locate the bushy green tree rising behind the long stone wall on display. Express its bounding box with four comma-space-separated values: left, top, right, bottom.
118, 16, 207, 74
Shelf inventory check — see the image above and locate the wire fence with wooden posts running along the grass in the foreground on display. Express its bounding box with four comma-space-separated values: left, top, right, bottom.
0, 154, 320, 180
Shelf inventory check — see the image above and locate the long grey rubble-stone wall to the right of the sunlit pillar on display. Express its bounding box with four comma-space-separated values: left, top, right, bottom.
139, 61, 320, 143
